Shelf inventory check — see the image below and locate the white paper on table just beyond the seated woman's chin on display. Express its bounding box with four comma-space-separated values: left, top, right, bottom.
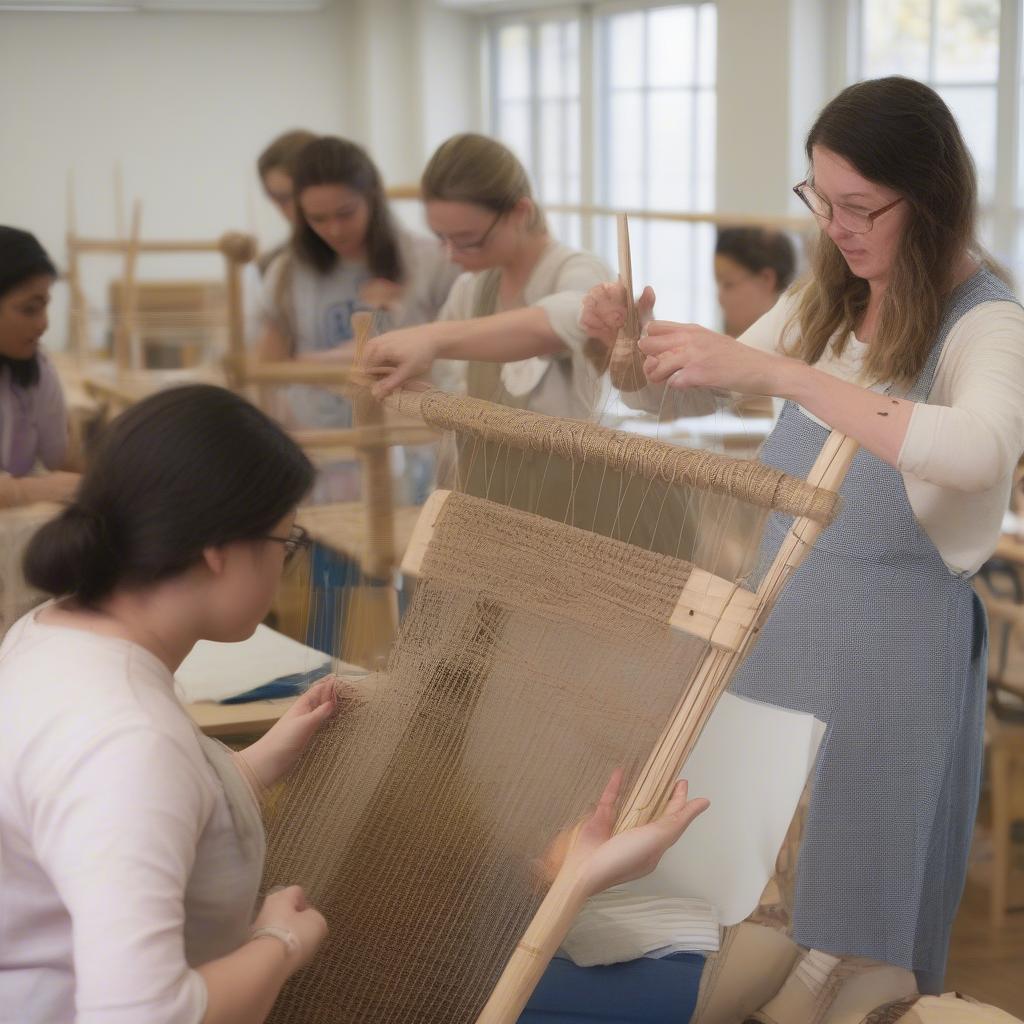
174, 625, 331, 701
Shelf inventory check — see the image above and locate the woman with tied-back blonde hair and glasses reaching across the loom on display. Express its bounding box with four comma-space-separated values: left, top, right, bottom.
368, 133, 610, 418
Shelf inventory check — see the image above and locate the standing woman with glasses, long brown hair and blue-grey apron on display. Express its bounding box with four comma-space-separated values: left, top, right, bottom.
584, 78, 1024, 1024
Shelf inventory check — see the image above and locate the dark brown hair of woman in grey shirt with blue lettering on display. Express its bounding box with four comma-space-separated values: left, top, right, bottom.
292, 135, 406, 285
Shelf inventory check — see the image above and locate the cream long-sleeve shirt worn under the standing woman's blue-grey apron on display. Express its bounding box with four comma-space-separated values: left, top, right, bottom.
623, 295, 1024, 573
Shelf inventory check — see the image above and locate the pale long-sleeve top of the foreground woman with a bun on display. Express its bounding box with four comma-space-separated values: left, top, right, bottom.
0, 606, 258, 1024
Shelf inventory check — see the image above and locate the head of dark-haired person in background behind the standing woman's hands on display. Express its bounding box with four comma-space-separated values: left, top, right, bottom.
715, 227, 797, 338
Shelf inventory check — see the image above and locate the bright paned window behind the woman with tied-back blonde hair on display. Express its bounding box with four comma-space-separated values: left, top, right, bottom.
488, 2, 718, 324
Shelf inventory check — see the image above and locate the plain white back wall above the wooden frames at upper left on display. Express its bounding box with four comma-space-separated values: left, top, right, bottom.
0, 8, 351, 345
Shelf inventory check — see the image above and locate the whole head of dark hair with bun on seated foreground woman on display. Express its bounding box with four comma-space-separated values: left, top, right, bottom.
24, 385, 314, 604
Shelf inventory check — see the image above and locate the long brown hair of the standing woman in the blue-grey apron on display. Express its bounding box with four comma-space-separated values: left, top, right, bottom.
790, 76, 1002, 384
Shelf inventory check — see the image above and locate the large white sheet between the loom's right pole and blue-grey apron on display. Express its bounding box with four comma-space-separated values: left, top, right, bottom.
627, 693, 824, 925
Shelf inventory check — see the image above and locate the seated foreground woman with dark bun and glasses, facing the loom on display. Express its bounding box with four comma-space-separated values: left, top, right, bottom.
0, 385, 707, 1024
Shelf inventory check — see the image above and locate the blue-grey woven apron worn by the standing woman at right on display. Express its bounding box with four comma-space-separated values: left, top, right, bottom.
732, 270, 1016, 992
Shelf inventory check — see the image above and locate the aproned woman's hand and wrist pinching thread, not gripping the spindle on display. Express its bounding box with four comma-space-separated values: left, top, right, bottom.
640, 321, 794, 395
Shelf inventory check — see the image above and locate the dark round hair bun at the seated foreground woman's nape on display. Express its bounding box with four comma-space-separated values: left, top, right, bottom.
24, 504, 117, 603
